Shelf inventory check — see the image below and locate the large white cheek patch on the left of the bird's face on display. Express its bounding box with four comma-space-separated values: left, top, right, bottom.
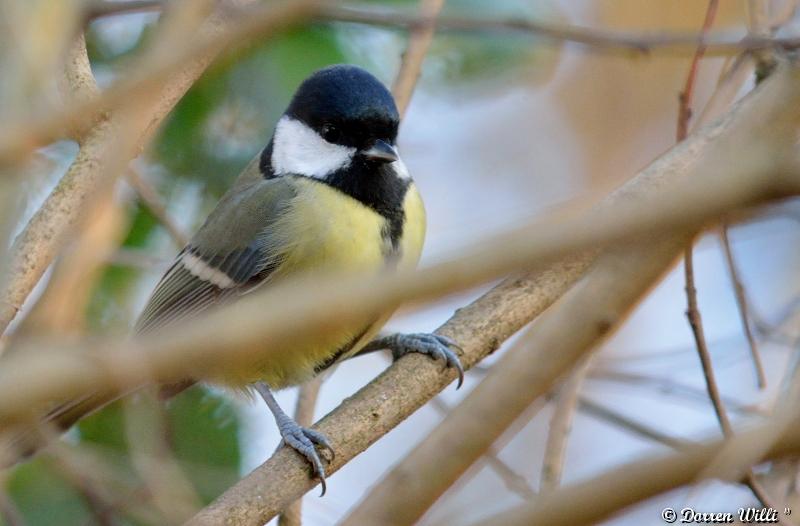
272, 117, 356, 179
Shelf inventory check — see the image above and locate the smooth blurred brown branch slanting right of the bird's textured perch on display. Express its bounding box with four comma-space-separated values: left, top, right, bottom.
341, 223, 690, 526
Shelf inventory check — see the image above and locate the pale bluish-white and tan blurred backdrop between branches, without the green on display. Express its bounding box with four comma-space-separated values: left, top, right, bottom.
14, 0, 800, 526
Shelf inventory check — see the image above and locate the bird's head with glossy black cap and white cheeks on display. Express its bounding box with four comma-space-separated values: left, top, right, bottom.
263, 64, 404, 179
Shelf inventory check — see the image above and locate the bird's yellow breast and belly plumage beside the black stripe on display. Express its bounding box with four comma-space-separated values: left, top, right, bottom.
223, 178, 425, 388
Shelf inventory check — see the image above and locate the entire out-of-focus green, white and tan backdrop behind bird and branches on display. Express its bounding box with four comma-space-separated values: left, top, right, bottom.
5, 0, 800, 525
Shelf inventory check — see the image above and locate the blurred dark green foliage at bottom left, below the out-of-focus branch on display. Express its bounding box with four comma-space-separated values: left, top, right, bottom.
7, 386, 241, 526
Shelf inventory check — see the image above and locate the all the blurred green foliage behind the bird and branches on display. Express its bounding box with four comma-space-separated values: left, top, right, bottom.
8, 6, 557, 526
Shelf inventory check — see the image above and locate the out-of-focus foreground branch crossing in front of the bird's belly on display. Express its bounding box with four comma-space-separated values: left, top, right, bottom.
6, 7, 797, 442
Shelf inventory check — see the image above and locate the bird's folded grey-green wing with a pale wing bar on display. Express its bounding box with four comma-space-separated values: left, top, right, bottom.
135, 178, 295, 333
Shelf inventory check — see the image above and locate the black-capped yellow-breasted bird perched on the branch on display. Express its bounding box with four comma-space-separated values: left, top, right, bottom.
12, 64, 464, 495
